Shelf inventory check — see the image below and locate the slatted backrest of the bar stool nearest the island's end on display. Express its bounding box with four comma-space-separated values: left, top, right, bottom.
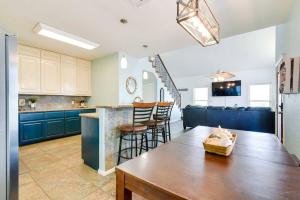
132, 102, 156, 126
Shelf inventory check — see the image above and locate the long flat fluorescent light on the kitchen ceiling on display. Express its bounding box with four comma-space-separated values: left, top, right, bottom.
33, 23, 99, 50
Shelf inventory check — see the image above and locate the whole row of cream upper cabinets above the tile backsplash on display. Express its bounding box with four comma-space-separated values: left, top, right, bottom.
18, 45, 91, 96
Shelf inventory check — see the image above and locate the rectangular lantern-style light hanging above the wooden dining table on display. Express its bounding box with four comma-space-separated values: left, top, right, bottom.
176, 0, 220, 47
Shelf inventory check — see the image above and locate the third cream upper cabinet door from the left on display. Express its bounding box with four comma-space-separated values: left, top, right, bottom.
61, 55, 77, 95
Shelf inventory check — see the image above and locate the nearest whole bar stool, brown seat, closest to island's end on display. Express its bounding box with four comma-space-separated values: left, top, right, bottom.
118, 102, 156, 165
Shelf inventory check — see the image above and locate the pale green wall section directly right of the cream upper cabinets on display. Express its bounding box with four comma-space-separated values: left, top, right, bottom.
88, 53, 119, 106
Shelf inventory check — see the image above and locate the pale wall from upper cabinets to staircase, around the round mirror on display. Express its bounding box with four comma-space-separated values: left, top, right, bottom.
88, 52, 181, 121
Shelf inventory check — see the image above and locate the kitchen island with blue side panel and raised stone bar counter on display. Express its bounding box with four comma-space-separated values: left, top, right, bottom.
80, 105, 133, 176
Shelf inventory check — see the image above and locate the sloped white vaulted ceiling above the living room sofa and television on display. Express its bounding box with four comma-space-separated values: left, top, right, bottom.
160, 27, 276, 78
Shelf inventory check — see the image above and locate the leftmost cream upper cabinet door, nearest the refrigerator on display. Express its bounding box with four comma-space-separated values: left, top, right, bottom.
18, 46, 41, 94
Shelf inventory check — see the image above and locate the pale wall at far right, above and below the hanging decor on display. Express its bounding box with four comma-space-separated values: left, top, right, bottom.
276, 1, 300, 158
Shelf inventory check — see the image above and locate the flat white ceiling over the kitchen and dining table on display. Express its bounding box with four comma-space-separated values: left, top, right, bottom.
0, 0, 294, 59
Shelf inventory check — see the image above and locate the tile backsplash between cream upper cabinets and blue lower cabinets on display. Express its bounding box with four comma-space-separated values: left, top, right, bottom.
19, 95, 87, 110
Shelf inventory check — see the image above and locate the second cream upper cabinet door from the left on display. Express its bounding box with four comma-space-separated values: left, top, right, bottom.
41, 50, 61, 94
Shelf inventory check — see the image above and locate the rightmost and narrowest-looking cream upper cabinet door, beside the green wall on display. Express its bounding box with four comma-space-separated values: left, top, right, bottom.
77, 59, 91, 96
